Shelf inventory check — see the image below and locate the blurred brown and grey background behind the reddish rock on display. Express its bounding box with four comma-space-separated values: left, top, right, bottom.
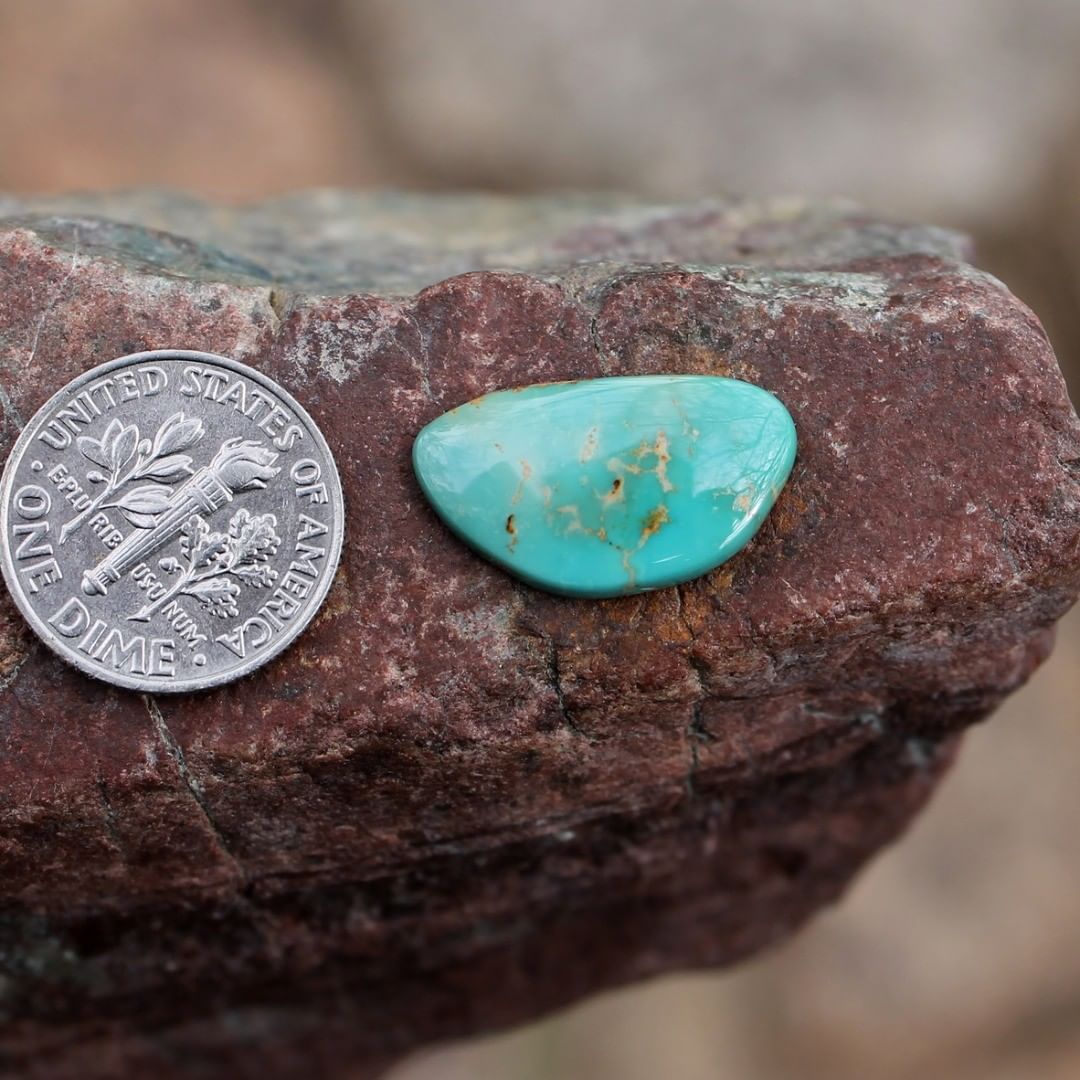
0, 0, 1080, 1080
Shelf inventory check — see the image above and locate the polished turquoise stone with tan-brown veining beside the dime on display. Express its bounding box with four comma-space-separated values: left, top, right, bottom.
413, 375, 795, 597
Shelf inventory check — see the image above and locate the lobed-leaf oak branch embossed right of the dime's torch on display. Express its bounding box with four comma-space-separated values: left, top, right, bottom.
129, 510, 281, 622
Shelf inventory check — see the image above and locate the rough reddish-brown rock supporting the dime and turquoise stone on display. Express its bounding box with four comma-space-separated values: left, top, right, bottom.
0, 192, 1080, 1080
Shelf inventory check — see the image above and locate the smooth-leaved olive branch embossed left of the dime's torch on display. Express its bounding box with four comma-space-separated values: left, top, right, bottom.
59, 413, 203, 543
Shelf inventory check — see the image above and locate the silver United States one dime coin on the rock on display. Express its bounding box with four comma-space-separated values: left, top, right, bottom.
0, 350, 345, 692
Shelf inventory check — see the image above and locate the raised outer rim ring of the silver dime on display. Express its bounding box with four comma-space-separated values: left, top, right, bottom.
0, 349, 346, 693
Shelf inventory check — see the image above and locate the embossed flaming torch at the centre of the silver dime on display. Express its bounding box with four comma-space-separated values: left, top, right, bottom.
82, 438, 281, 596
